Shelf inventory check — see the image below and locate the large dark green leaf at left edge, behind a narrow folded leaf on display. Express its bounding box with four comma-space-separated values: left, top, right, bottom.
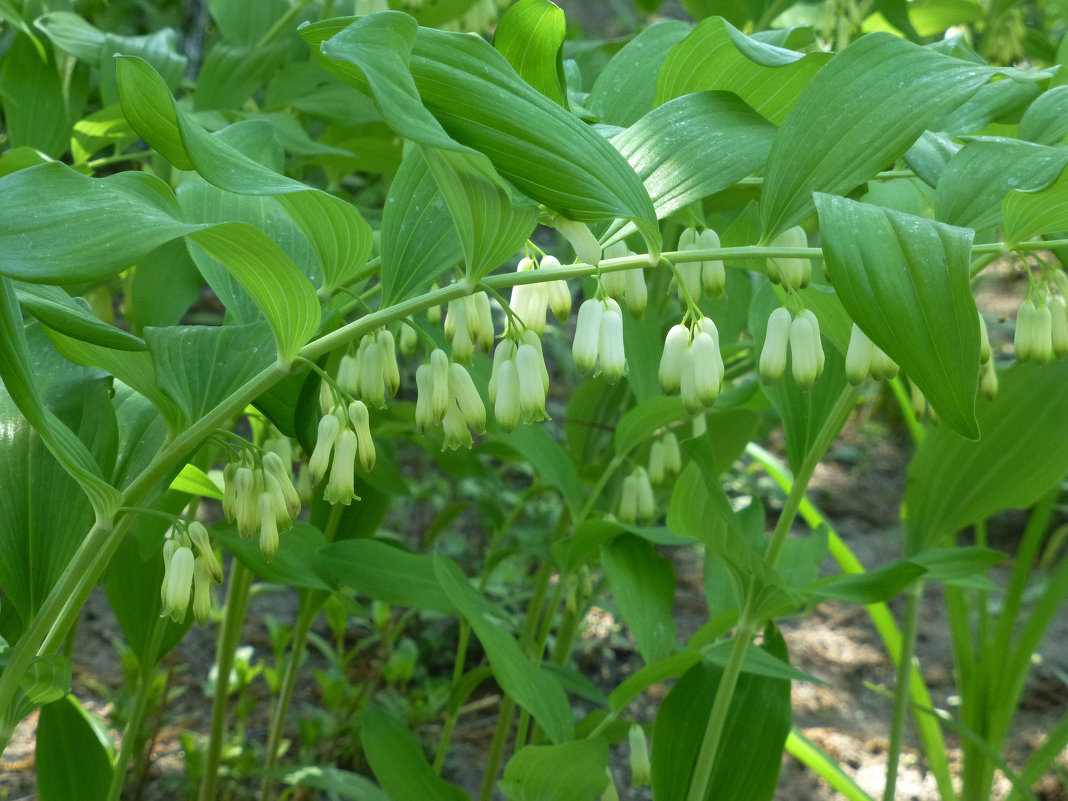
0, 322, 119, 634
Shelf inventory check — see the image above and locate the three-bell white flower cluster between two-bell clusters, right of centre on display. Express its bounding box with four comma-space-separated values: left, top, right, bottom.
659, 317, 723, 414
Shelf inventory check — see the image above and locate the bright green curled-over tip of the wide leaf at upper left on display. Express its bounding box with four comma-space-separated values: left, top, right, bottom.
190, 222, 321, 365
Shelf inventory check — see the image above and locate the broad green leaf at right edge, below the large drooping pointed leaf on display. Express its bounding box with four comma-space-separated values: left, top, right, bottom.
905, 360, 1068, 553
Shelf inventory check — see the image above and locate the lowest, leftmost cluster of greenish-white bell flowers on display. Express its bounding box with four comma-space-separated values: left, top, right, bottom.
159, 520, 222, 626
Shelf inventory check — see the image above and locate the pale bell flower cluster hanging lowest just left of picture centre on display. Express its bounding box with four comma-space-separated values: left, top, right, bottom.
415, 349, 486, 450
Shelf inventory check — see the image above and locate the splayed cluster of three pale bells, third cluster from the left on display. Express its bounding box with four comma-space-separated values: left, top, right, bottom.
309, 401, 375, 508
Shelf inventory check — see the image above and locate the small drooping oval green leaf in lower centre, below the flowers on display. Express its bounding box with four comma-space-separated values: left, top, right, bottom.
601, 534, 675, 664
